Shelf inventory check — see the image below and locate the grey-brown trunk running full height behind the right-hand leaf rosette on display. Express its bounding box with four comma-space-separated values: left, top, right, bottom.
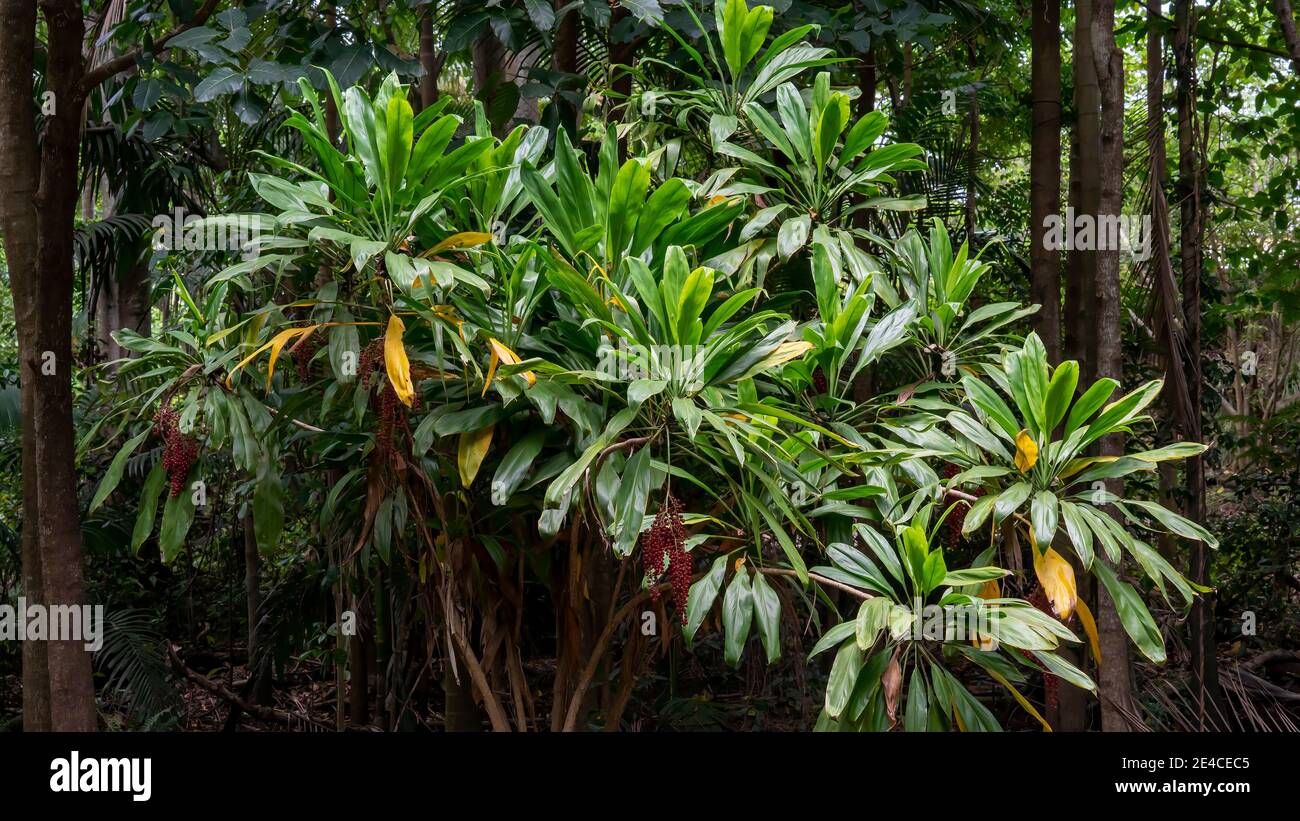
1092, 0, 1134, 731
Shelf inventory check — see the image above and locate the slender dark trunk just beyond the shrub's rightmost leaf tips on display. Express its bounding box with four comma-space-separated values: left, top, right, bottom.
1174, 0, 1218, 720
